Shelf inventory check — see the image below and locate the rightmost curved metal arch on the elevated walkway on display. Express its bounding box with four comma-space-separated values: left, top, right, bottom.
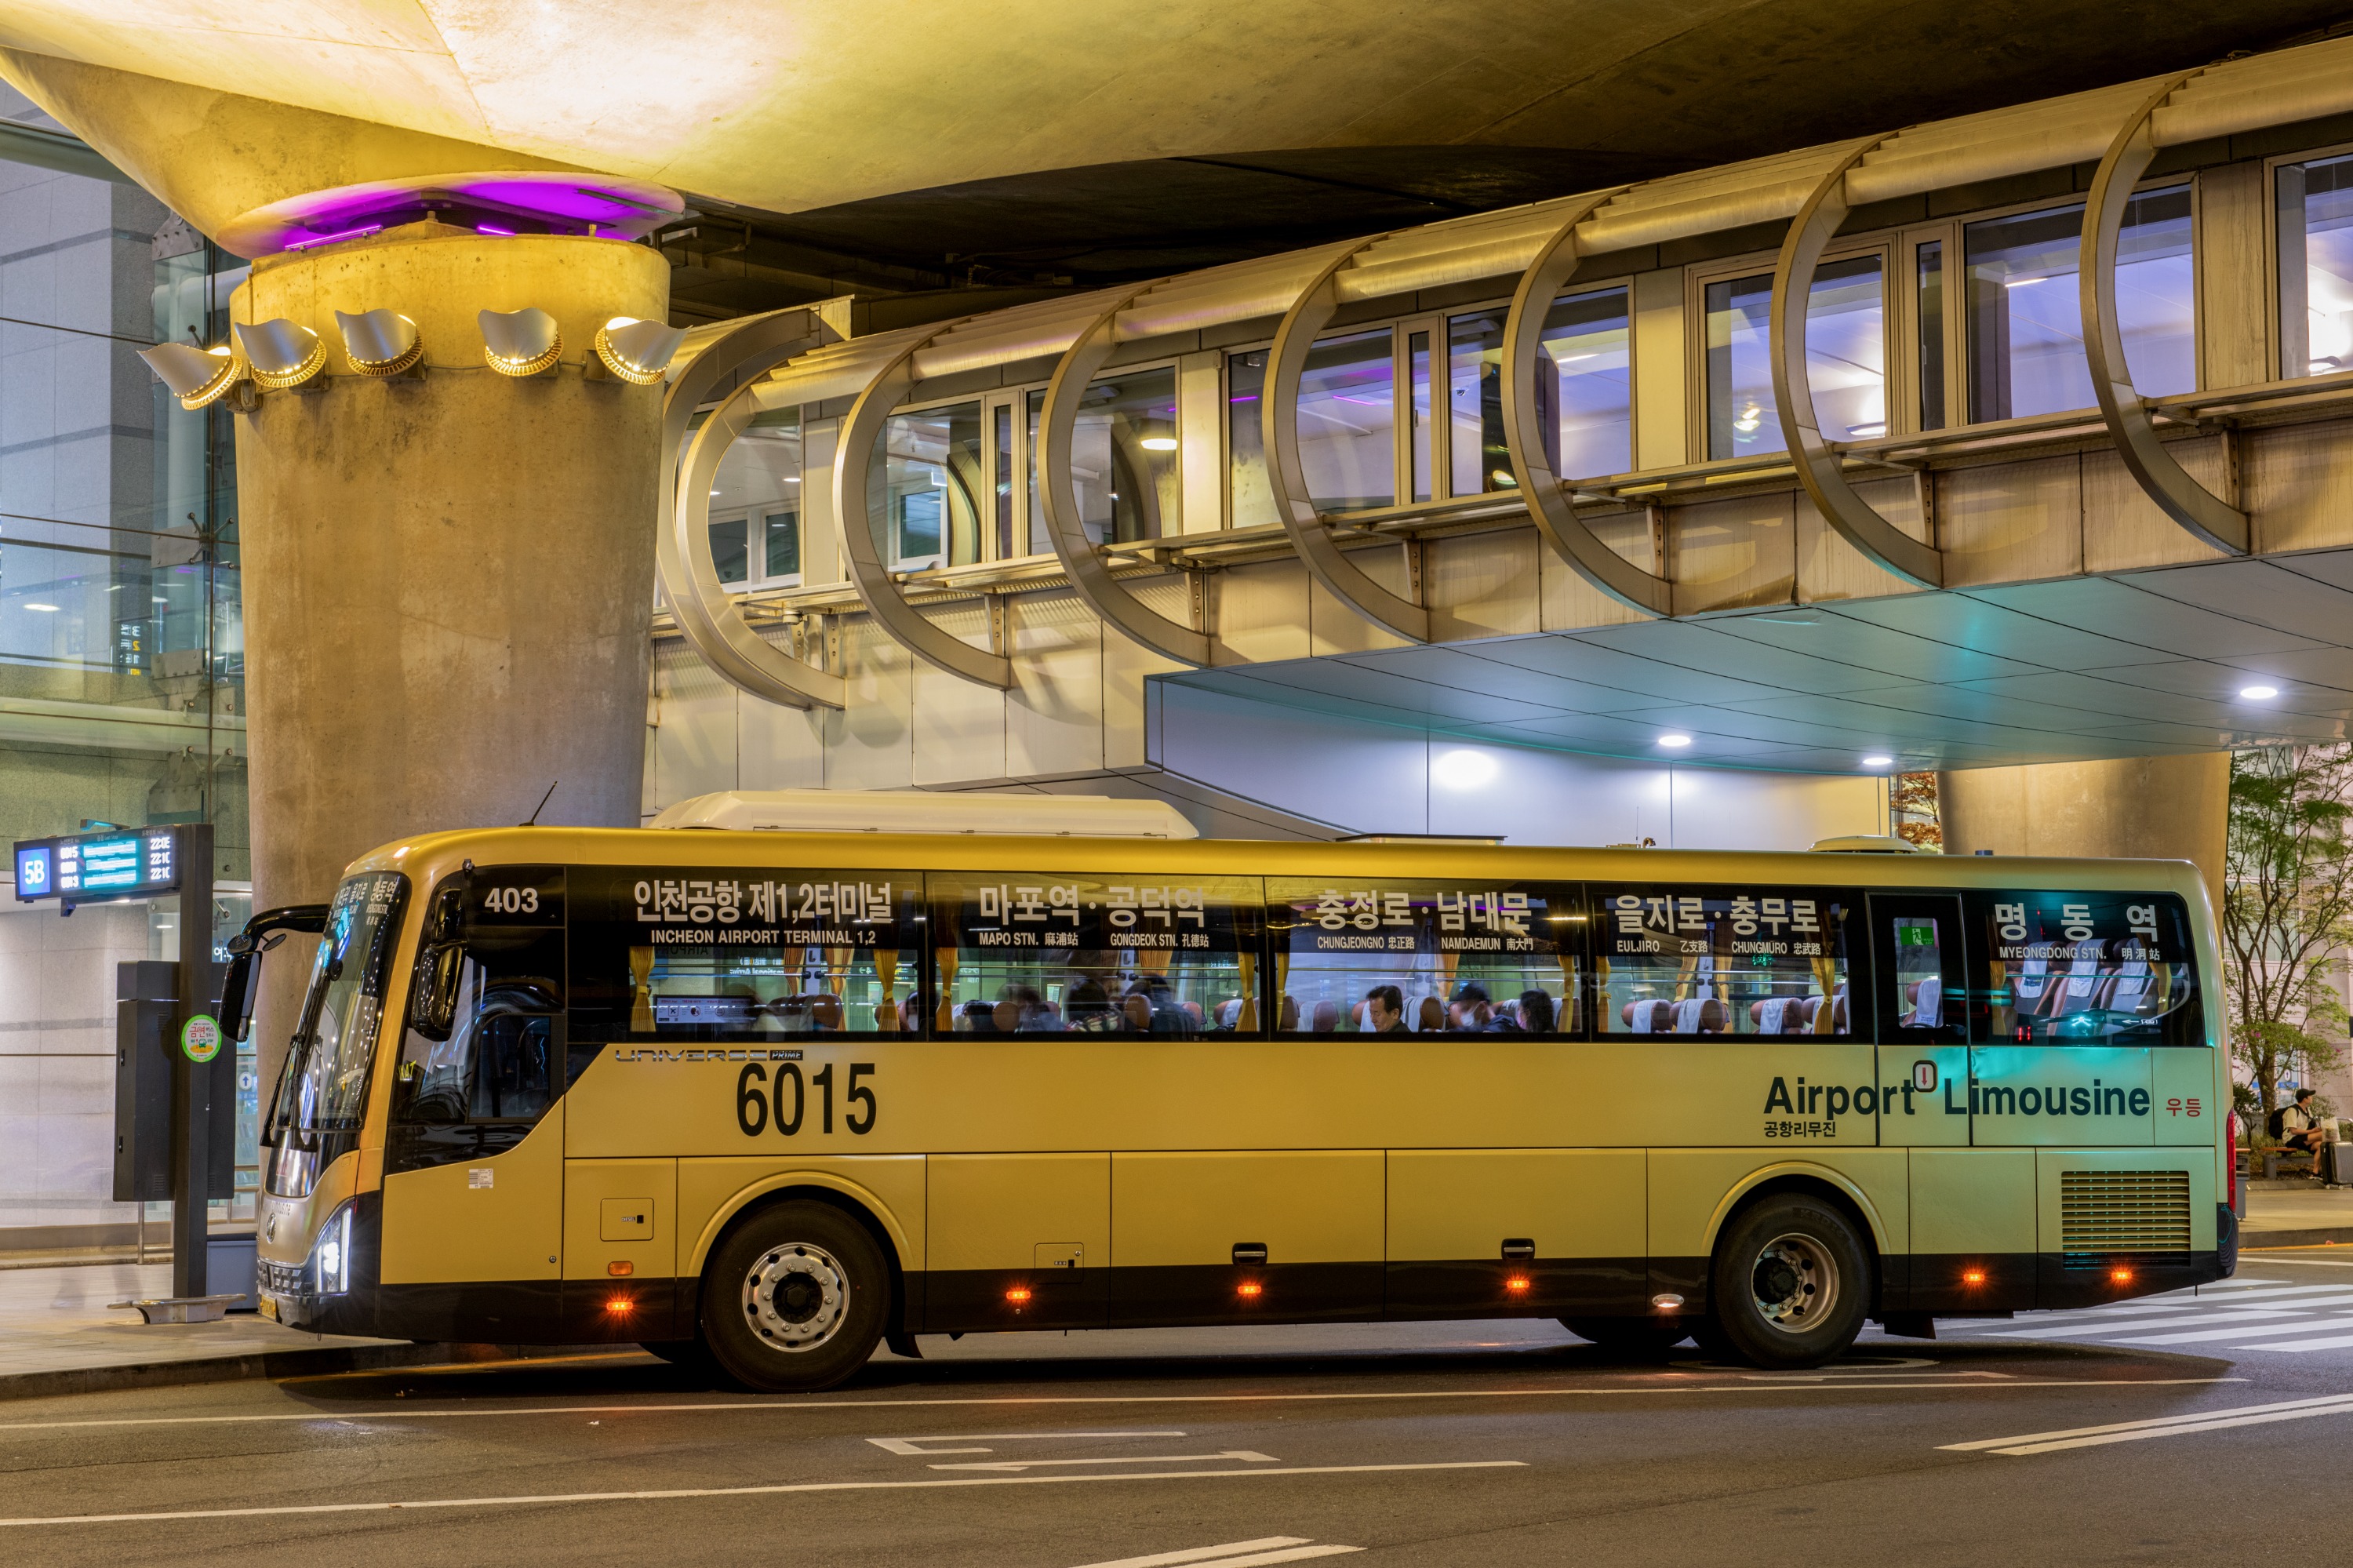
2078, 71, 2252, 555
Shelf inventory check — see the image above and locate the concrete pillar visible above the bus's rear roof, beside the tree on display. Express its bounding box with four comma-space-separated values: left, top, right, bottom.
1937, 751, 2231, 909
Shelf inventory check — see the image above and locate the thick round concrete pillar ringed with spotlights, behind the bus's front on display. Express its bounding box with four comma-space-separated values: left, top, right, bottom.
231, 224, 668, 1081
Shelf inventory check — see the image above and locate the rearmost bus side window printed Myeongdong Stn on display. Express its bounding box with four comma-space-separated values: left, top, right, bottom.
1969, 890, 2205, 1046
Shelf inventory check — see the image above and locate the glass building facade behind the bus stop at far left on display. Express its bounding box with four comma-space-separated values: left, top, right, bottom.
0, 87, 259, 1250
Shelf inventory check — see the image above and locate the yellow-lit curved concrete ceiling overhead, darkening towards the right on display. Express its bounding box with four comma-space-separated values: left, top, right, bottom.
13, 0, 2344, 308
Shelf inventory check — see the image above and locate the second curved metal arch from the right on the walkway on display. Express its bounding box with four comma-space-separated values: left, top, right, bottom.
1769, 136, 1944, 588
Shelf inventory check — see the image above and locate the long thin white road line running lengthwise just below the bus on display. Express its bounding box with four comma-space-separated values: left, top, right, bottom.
0, 1374, 2261, 1432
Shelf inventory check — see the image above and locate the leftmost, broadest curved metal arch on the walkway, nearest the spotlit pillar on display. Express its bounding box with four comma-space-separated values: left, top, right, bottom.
654, 311, 845, 708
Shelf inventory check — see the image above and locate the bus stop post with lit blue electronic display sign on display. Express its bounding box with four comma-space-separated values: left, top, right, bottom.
16, 822, 242, 1323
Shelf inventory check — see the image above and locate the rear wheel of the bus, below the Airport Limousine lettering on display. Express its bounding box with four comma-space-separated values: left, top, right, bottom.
1708, 1191, 1871, 1368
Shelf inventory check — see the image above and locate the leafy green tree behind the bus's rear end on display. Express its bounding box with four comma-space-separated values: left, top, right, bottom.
2221, 744, 2353, 1121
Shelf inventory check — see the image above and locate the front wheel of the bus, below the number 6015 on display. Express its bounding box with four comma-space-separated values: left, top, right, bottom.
701, 1203, 889, 1394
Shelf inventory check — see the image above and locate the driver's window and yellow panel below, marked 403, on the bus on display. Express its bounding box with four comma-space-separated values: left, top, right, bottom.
384, 867, 565, 1337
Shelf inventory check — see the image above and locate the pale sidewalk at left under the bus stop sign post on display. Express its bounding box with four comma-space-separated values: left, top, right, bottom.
0, 1262, 494, 1399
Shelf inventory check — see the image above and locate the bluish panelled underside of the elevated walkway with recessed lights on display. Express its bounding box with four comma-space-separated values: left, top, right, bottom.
1160, 551, 2353, 772
